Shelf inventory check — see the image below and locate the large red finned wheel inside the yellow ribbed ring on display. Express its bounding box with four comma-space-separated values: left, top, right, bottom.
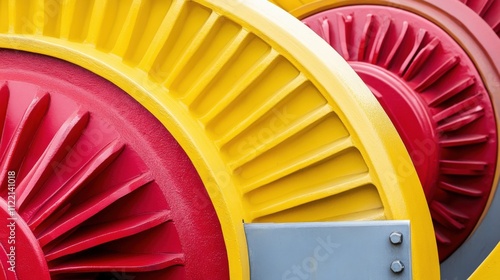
0, 50, 229, 280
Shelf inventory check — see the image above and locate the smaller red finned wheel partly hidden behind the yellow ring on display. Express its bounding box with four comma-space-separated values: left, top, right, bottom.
304, 5, 497, 260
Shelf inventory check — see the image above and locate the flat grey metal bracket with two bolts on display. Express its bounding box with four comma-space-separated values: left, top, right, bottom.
245, 221, 412, 280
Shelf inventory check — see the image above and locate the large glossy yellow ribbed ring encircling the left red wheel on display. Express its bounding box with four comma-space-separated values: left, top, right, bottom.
0, 0, 438, 279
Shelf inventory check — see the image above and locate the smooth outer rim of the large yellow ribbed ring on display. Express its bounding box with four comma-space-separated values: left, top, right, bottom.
200, 0, 439, 279
